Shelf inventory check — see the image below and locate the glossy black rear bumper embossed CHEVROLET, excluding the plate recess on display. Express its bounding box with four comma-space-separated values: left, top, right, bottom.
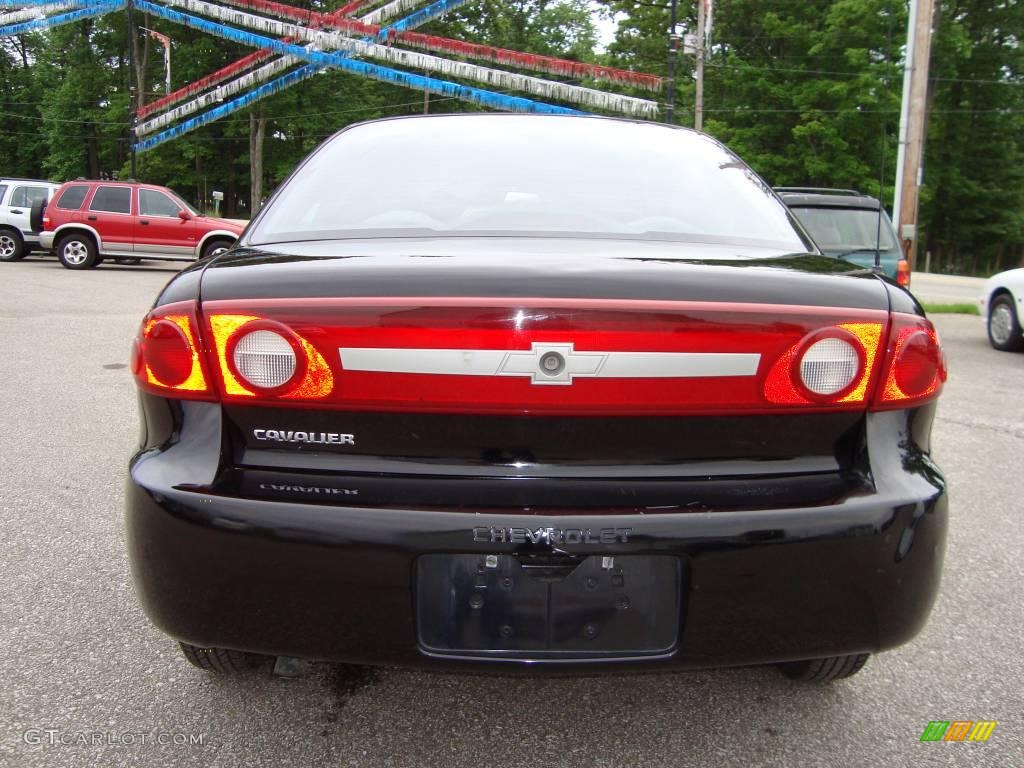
127, 407, 947, 671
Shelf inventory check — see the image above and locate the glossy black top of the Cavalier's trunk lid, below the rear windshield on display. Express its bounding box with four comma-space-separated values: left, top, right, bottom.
195, 243, 889, 309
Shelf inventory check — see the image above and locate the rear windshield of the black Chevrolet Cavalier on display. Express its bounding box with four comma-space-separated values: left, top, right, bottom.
247, 116, 809, 251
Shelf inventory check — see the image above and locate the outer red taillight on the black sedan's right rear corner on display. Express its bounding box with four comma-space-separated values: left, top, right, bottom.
874, 314, 946, 409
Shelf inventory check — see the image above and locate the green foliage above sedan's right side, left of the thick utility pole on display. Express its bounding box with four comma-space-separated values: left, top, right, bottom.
607, 0, 906, 195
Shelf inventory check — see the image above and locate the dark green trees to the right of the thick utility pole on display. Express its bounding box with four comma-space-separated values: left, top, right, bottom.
922, 0, 1024, 274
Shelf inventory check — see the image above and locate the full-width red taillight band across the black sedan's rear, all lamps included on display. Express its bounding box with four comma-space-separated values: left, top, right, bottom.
132, 299, 946, 415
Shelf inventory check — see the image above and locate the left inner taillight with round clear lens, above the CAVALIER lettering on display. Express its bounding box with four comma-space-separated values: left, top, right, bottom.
209, 314, 334, 399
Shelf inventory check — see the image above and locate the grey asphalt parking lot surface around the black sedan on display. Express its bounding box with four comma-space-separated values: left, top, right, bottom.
0, 257, 1024, 768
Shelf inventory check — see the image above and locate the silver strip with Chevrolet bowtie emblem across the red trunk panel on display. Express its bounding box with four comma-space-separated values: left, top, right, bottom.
338, 341, 761, 385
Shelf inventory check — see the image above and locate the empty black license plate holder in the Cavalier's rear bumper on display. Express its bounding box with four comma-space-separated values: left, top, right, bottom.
416, 554, 681, 659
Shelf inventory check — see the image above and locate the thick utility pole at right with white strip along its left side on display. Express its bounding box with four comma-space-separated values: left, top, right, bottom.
893, 0, 935, 270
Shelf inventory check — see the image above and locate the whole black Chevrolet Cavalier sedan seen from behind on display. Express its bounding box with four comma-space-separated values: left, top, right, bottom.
127, 115, 947, 681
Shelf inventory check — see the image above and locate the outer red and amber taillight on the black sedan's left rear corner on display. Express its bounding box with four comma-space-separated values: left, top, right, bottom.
131, 301, 211, 399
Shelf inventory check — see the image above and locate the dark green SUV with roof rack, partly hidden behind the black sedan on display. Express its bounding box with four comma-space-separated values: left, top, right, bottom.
775, 186, 910, 288
